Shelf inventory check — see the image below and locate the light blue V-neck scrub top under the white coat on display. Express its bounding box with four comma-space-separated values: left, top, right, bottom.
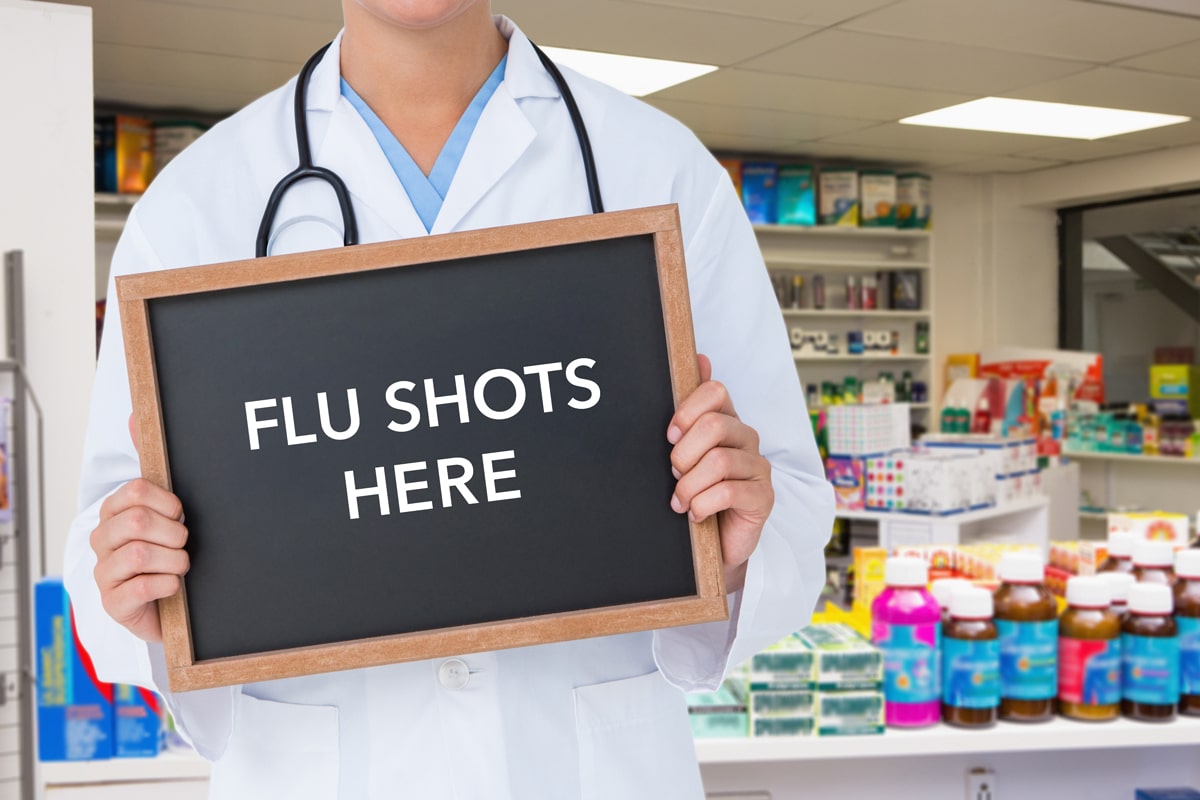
342, 55, 509, 233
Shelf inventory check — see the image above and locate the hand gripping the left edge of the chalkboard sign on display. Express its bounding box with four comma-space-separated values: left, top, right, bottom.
91, 419, 188, 642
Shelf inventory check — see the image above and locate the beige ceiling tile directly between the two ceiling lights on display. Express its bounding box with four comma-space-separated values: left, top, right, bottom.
653, 70, 973, 120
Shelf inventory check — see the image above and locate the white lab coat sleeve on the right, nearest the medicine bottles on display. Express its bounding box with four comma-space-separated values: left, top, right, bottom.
654, 170, 834, 691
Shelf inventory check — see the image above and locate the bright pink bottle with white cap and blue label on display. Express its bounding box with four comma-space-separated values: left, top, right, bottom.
871, 557, 942, 728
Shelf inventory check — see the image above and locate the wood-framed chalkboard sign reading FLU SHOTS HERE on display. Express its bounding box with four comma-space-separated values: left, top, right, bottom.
116, 206, 727, 691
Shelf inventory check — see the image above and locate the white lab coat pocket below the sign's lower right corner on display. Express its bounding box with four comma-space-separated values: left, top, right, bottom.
575, 672, 704, 800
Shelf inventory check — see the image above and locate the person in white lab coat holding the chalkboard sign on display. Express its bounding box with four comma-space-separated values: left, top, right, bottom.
65, 0, 833, 800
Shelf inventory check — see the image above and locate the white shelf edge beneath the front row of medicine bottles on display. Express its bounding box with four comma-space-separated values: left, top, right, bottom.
696, 717, 1200, 764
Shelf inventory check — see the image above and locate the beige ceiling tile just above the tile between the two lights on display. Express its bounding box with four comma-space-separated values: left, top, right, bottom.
738, 30, 1092, 95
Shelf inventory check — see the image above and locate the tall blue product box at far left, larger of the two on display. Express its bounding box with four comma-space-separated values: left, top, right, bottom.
34, 578, 113, 762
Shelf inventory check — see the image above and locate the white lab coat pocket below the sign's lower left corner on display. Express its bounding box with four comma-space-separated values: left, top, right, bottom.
209, 693, 338, 800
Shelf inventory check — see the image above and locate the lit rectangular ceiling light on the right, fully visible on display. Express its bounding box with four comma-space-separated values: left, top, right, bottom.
900, 97, 1190, 139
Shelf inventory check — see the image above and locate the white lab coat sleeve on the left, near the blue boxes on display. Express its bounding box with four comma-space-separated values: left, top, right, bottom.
62, 209, 234, 758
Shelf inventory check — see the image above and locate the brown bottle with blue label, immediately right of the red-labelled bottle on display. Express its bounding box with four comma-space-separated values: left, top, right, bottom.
1121, 583, 1180, 722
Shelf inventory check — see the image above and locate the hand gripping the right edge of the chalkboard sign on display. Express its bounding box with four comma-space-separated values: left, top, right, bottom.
667, 355, 775, 591
